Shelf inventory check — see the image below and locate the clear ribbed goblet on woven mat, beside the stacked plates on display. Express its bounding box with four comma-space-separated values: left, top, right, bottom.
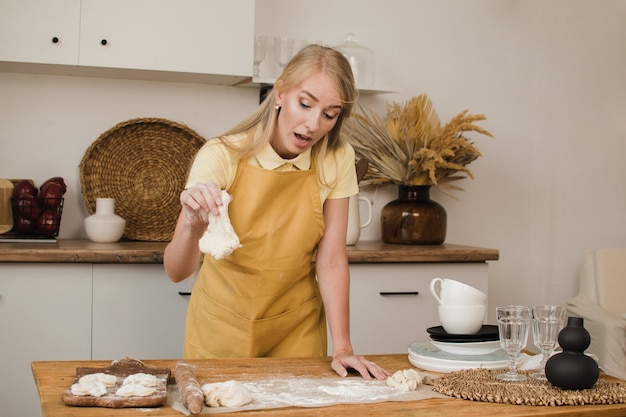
496, 305, 532, 381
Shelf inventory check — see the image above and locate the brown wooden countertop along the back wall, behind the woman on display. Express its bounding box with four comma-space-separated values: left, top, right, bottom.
0, 239, 499, 264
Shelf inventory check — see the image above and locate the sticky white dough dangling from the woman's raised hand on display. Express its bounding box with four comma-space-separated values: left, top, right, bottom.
198, 190, 241, 259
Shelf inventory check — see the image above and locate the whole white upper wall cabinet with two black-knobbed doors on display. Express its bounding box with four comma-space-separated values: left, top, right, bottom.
0, 0, 254, 85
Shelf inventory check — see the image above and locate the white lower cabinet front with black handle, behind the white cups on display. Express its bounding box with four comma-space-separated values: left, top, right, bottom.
350, 263, 488, 354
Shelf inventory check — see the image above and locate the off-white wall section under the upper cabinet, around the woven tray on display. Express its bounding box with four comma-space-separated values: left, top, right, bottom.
0, 73, 259, 238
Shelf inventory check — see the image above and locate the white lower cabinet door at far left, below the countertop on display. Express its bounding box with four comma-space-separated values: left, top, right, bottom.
0, 263, 91, 417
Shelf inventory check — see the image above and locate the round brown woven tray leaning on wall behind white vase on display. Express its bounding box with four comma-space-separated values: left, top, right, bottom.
80, 118, 205, 241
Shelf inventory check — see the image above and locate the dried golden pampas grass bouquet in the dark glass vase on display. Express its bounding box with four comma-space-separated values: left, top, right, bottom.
344, 94, 493, 197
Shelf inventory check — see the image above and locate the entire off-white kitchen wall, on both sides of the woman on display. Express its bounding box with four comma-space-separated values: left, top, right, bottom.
0, 0, 626, 324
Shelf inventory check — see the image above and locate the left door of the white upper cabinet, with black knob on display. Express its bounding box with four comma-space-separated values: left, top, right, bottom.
0, 0, 80, 65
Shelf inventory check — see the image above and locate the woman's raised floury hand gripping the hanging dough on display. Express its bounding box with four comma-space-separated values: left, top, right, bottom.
180, 182, 223, 227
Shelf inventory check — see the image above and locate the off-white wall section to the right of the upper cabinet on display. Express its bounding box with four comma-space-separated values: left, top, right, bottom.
256, 0, 626, 321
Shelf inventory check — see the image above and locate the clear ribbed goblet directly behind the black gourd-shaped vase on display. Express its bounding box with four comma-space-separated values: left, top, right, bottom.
530, 305, 565, 381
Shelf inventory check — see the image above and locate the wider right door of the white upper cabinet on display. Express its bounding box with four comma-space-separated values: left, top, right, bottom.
79, 0, 254, 76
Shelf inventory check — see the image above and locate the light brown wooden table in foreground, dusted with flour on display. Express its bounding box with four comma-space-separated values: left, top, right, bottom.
32, 354, 626, 417
